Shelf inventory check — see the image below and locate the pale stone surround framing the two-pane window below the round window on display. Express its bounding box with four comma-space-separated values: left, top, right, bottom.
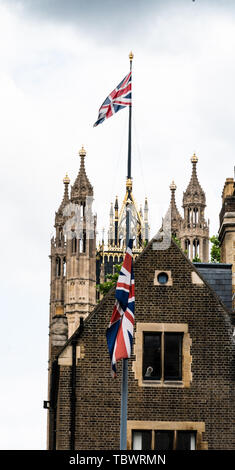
132, 322, 192, 388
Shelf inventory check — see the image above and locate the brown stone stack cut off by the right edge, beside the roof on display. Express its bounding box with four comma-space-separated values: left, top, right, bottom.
219, 173, 235, 308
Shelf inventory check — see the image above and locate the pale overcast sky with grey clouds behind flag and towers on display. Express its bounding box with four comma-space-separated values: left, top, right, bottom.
0, 0, 235, 449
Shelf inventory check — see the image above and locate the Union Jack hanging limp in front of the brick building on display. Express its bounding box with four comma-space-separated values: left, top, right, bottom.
106, 240, 135, 377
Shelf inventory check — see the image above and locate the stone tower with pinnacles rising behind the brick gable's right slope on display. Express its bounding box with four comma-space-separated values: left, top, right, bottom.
170, 154, 209, 263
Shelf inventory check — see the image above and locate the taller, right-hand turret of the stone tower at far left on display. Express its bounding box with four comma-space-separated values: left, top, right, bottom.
65, 147, 96, 336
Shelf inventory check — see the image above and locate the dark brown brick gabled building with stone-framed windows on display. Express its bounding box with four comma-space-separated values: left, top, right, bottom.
48, 241, 235, 450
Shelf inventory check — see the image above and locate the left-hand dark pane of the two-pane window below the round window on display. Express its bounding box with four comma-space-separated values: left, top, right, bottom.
143, 333, 161, 380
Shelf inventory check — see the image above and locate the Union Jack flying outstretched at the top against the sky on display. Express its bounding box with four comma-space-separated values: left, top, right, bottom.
93, 72, 131, 127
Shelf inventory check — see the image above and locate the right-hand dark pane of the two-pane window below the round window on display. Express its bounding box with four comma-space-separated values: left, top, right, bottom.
164, 333, 182, 380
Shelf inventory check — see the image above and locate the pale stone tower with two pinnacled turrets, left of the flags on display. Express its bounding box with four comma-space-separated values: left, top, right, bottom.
50, 147, 96, 346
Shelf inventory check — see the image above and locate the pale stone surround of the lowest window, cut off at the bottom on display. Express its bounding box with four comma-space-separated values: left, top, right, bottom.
127, 421, 208, 450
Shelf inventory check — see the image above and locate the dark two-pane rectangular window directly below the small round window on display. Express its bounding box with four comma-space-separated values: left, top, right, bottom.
143, 332, 183, 380
